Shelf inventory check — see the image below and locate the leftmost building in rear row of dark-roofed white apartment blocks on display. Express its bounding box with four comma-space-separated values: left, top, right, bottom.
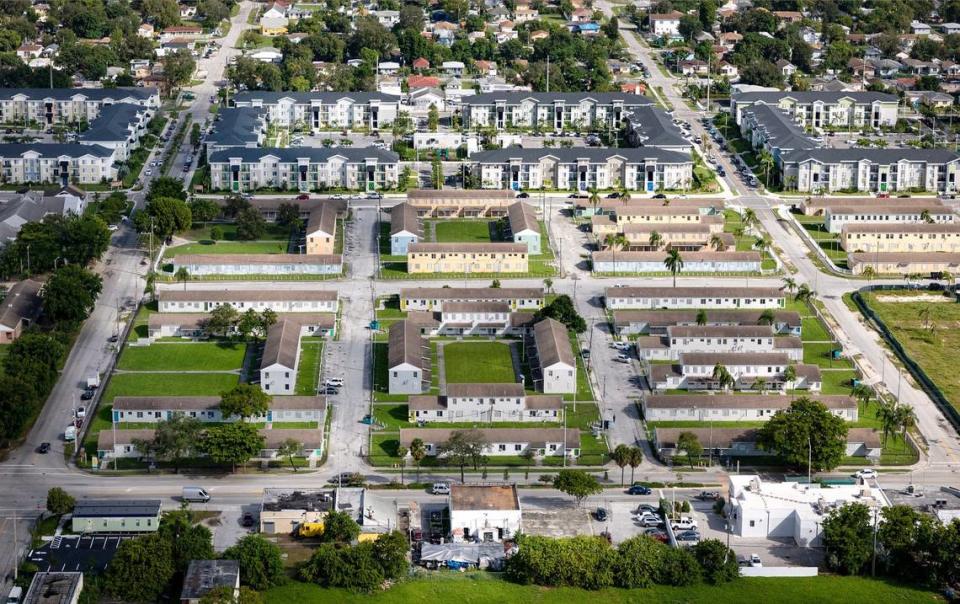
0, 87, 160, 126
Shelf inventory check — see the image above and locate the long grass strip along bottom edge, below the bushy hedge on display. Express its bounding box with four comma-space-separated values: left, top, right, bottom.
263, 571, 942, 604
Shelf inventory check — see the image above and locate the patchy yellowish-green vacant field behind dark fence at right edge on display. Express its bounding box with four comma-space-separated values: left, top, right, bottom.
863, 291, 960, 408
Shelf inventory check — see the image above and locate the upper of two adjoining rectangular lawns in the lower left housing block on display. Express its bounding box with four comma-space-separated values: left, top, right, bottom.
117, 342, 246, 371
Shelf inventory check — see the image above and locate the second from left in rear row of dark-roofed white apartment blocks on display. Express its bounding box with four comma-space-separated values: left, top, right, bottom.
233, 90, 401, 132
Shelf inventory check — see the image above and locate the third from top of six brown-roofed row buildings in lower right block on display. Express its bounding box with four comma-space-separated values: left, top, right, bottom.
635, 325, 803, 362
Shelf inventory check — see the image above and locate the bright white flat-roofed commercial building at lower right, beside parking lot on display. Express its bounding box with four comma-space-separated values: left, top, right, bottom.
727, 475, 890, 547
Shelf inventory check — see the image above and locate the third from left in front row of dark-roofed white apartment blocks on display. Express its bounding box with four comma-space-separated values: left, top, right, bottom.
470, 147, 693, 192
